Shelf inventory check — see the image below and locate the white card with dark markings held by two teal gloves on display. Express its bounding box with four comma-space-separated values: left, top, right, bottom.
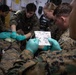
35, 31, 51, 45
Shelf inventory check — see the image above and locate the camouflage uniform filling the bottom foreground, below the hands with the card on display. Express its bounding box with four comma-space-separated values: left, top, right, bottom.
7, 49, 76, 75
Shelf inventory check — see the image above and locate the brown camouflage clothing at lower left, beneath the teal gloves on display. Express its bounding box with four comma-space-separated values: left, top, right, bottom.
0, 39, 21, 75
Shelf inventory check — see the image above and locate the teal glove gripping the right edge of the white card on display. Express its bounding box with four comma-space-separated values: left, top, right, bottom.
48, 38, 62, 51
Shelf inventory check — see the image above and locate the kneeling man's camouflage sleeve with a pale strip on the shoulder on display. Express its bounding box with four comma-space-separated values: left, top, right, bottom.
10, 10, 21, 25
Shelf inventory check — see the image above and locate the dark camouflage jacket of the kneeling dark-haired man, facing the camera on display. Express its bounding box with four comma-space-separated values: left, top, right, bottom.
10, 10, 39, 35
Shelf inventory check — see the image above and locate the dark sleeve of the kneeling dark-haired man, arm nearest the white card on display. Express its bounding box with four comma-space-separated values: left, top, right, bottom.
31, 15, 40, 34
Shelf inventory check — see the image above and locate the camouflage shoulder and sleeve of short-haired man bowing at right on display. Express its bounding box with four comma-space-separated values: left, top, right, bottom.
59, 30, 76, 50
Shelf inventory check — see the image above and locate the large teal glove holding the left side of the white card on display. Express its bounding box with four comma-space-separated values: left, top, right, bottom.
26, 38, 39, 54
